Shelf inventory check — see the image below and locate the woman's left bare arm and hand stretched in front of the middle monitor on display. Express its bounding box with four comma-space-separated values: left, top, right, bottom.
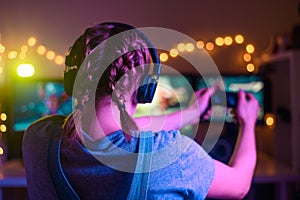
135, 88, 214, 131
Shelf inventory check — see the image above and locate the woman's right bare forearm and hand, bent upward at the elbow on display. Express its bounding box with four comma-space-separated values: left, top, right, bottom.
208, 91, 258, 199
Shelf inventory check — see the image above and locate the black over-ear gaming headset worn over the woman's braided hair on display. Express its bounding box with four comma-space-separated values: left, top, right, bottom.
64, 22, 161, 104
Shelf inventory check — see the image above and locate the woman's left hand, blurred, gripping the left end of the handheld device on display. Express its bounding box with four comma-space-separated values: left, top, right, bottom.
188, 87, 215, 122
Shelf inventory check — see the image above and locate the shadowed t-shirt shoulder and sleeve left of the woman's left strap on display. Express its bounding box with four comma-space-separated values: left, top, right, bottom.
22, 115, 65, 199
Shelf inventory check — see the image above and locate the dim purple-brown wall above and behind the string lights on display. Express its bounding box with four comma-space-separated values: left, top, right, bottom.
0, 0, 300, 77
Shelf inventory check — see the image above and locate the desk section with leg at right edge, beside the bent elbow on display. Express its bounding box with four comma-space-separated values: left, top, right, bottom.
253, 152, 300, 200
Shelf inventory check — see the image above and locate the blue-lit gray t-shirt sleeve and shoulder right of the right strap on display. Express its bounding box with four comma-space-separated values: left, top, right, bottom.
150, 130, 215, 200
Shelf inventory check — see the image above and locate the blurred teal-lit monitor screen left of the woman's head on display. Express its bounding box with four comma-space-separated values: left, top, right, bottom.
13, 80, 73, 132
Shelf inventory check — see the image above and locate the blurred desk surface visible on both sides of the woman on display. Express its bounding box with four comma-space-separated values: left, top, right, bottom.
0, 153, 300, 187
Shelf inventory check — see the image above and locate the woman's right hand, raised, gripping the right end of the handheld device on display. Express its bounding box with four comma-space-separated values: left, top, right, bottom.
237, 90, 259, 125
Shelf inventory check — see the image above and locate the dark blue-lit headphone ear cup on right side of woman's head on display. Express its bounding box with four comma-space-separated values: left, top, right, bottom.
137, 75, 157, 103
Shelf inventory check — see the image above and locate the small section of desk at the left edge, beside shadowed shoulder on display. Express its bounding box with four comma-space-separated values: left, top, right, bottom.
0, 160, 27, 200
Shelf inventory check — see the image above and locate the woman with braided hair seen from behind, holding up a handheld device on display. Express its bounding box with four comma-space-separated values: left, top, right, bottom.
23, 23, 258, 199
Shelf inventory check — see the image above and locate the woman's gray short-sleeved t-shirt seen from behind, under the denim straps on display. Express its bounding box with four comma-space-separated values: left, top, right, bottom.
23, 116, 214, 200
